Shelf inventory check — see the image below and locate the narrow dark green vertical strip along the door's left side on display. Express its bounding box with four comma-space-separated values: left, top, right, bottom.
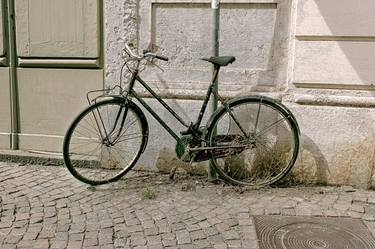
6, 0, 20, 150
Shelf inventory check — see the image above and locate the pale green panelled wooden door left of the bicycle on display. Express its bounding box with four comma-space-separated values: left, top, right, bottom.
0, 0, 103, 152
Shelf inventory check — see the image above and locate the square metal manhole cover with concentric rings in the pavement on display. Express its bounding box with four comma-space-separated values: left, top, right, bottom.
255, 216, 375, 249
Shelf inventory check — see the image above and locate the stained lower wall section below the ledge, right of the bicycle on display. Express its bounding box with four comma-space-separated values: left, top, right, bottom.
287, 98, 375, 188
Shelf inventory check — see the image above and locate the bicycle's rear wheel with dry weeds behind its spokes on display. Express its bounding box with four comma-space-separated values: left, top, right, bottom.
206, 97, 299, 186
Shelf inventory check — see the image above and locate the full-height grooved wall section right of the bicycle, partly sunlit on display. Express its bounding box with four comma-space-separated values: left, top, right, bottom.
284, 0, 375, 188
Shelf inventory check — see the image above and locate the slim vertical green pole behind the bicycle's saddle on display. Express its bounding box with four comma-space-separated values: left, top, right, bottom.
208, 0, 220, 181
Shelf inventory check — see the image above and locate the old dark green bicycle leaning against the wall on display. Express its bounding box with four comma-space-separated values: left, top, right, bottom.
63, 45, 299, 186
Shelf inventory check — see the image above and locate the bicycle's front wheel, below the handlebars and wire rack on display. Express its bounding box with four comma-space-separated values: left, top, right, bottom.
63, 99, 148, 185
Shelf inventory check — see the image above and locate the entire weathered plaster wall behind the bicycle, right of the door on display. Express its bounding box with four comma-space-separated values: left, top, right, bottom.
105, 0, 375, 188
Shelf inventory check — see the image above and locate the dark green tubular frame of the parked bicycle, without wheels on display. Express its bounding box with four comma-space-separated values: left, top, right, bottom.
125, 66, 220, 141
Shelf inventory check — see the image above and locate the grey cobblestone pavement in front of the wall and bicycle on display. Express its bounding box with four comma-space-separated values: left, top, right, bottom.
0, 163, 375, 249
